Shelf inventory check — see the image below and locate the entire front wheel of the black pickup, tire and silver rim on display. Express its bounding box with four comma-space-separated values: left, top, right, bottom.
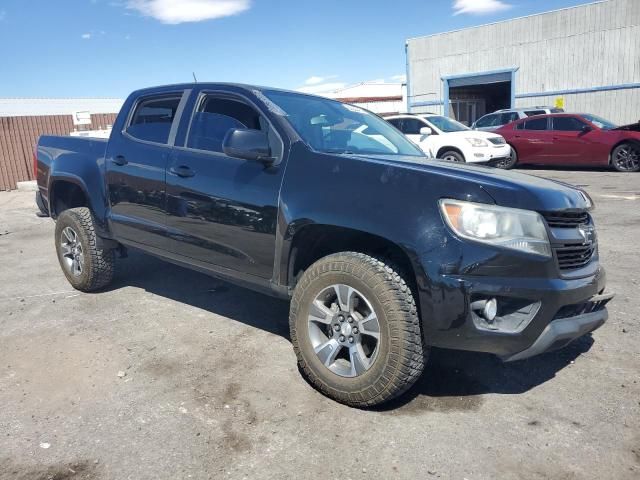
289, 252, 425, 407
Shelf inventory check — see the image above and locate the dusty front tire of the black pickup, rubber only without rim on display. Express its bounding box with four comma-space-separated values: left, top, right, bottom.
289, 252, 426, 407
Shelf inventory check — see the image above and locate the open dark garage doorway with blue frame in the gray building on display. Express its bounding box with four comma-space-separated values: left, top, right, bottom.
442, 69, 515, 126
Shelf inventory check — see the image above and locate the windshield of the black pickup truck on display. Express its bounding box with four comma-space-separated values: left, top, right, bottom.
262, 90, 424, 157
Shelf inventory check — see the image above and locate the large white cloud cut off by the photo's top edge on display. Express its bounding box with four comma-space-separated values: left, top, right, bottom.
126, 0, 251, 24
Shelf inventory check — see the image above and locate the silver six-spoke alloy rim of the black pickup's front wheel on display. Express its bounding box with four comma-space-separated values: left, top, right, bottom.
308, 284, 380, 378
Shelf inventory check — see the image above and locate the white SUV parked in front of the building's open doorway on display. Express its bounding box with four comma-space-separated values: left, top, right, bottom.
384, 113, 511, 163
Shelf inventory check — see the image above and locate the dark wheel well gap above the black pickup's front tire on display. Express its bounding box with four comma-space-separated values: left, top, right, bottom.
288, 225, 416, 292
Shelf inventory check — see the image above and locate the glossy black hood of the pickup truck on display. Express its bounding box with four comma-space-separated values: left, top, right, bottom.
366, 155, 590, 212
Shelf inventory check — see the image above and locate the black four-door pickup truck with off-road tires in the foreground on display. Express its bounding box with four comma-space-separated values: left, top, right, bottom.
36, 83, 612, 406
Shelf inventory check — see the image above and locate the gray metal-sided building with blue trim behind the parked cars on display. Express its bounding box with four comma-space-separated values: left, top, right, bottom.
406, 0, 640, 124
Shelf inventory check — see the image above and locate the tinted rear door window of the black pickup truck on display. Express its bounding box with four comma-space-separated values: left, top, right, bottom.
126, 94, 182, 144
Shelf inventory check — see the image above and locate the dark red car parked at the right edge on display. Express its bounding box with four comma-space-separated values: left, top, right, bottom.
495, 113, 640, 172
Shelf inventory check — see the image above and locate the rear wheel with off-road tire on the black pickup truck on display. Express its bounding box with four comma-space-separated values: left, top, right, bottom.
55, 207, 115, 292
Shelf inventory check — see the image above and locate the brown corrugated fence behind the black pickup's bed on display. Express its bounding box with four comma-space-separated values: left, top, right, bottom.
0, 113, 116, 191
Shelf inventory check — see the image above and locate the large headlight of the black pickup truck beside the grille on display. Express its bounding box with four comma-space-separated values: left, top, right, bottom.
440, 199, 551, 257
